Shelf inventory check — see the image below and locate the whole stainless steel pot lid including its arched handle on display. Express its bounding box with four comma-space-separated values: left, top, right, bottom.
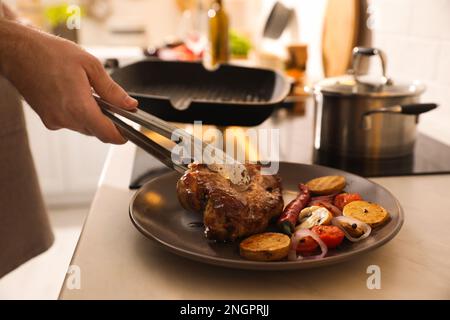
314, 47, 425, 97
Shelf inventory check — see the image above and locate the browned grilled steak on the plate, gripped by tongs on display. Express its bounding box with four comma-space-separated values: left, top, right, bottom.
177, 164, 284, 241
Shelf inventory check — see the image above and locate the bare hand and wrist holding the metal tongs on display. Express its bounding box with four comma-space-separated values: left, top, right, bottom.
0, 19, 137, 144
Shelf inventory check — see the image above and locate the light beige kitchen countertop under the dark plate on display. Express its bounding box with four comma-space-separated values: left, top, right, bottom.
60, 137, 450, 299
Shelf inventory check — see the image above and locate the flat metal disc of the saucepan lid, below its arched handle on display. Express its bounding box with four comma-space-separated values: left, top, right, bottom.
314, 75, 425, 97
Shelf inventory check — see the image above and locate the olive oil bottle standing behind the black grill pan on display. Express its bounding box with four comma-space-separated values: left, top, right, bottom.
203, 0, 230, 70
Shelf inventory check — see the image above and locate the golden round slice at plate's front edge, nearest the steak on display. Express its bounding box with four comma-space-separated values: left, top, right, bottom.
239, 232, 291, 261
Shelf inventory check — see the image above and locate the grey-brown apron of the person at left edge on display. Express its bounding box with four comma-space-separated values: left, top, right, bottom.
0, 75, 53, 278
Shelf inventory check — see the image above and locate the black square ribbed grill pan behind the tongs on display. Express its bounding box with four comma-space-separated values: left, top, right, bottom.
111, 59, 291, 126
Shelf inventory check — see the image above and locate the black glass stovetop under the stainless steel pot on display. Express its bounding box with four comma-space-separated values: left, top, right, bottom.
130, 108, 450, 189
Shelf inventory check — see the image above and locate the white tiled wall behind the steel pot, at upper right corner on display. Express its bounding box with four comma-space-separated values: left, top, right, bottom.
370, 0, 450, 143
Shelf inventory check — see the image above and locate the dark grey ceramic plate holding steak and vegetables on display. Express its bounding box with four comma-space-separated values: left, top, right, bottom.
130, 163, 403, 270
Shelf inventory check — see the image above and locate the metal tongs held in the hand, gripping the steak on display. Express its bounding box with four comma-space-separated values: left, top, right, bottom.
93, 93, 250, 185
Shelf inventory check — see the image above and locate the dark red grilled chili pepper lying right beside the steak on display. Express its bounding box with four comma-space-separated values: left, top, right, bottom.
277, 183, 311, 235
